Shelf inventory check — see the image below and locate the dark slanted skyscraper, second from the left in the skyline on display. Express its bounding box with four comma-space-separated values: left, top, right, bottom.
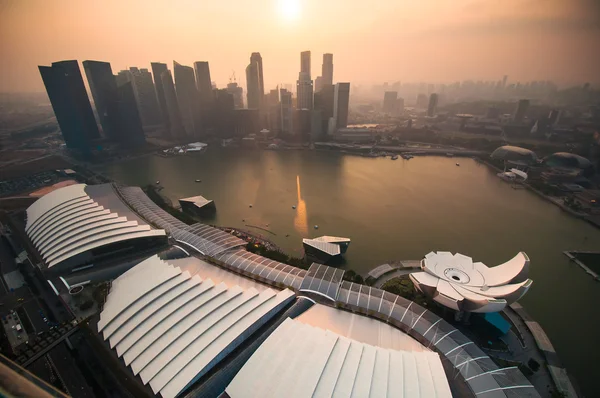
83, 61, 121, 141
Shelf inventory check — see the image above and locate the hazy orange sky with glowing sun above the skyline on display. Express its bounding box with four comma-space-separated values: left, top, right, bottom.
0, 0, 600, 91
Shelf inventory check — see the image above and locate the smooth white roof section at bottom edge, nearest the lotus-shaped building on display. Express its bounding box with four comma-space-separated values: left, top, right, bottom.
225, 318, 452, 398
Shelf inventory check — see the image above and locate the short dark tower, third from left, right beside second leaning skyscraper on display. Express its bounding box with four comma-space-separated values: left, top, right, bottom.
117, 82, 146, 148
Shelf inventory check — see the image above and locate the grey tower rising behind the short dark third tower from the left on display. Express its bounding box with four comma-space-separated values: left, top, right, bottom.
128, 67, 162, 126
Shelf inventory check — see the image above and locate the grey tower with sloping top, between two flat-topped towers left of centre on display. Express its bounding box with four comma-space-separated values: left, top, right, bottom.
173, 61, 202, 137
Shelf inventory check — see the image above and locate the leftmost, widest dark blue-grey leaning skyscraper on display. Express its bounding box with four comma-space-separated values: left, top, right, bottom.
39, 61, 100, 152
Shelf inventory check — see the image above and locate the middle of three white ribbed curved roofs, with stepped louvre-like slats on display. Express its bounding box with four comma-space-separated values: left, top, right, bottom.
98, 256, 294, 397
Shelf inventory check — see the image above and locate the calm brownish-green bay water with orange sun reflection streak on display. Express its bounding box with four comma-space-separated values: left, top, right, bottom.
99, 148, 600, 396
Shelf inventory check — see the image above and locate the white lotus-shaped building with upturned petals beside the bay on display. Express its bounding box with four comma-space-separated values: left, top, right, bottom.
410, 252, 533, 312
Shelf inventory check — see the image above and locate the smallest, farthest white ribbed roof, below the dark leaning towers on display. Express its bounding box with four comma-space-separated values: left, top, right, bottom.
25, 184, 165, 267
